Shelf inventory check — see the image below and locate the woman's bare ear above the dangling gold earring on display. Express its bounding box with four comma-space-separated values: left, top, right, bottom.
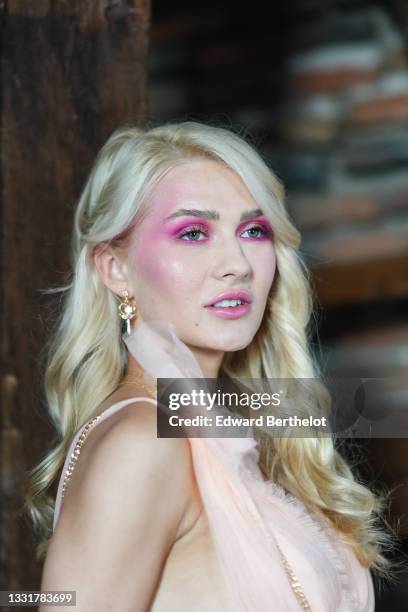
92, 244, 130, 295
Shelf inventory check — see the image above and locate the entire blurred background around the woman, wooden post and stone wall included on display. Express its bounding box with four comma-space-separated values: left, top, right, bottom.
0, 0, 408, 612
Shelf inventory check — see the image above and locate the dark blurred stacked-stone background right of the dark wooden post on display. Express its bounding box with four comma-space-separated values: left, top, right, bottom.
147, 0, 408, 611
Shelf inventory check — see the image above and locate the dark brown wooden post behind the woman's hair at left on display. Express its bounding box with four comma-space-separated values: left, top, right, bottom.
0, 0, 150, 596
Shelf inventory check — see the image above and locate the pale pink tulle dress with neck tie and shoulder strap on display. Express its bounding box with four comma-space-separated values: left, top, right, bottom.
54, 321, 374, 612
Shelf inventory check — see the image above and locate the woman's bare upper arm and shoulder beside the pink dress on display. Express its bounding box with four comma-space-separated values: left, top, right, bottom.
39, 402, 191, 612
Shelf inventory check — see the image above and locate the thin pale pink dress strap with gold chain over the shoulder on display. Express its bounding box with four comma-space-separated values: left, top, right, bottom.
53, 397, 157, 531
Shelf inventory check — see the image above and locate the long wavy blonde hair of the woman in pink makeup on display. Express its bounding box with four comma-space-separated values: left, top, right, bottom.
26, 121, 394, 578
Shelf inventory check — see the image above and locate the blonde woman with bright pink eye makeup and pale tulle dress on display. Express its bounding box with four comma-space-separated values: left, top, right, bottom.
29, 122, 396, 612
